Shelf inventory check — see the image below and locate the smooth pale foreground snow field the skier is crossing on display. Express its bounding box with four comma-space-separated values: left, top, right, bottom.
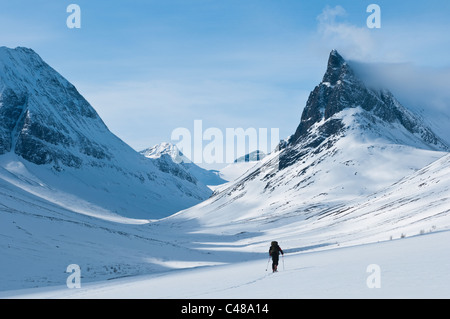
0, 231, 450, 299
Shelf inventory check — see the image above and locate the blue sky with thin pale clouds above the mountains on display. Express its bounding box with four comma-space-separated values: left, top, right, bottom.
0, 0, 450, 168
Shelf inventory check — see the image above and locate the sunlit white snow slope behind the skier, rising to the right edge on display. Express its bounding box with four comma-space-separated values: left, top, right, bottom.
159, 155, 450, 258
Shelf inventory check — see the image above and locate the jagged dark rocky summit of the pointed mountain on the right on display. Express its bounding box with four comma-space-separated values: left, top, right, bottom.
289, 50, 449, 151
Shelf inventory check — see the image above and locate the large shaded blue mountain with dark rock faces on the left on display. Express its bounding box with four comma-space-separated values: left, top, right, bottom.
0, 47, 211, 218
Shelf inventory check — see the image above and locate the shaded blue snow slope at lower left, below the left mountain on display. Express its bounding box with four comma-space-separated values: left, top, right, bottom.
0, 168, 223, 290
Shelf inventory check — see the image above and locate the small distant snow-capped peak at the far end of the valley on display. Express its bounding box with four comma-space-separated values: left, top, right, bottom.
140, 142, 227, 186
